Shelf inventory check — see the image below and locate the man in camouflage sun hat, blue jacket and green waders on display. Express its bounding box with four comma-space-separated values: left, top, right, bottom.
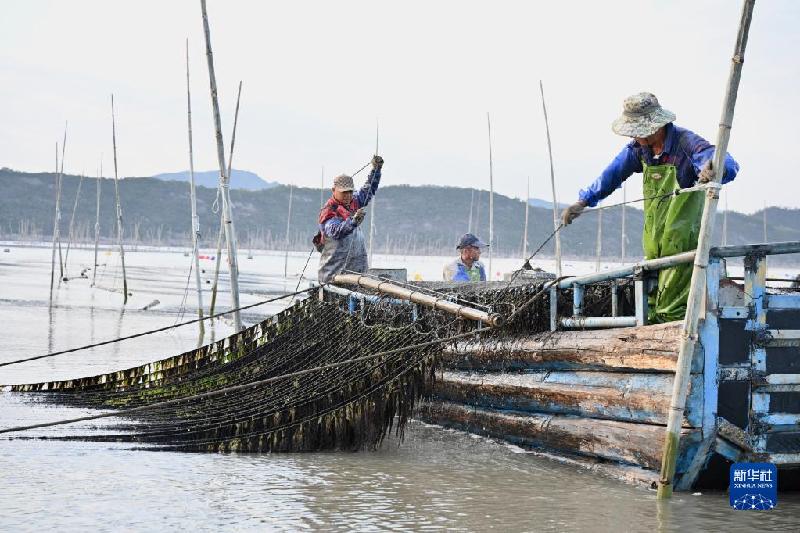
561, 93, 739, 322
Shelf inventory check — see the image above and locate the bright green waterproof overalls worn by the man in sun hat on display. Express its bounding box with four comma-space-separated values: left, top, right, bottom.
642, 160, 705, 323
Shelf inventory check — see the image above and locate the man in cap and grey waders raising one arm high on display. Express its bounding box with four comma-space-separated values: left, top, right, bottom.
314, 155, 383, 283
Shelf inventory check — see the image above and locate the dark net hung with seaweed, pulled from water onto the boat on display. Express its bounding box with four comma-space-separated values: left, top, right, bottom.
7, 279, 631, 452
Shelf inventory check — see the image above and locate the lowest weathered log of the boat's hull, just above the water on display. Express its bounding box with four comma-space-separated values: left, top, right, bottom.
418, 402, 700, 470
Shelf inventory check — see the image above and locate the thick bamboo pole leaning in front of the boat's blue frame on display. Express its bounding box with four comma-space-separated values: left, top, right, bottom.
658, 0, 755, 499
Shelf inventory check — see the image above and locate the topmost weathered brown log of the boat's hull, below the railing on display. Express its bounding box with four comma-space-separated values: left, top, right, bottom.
443, 322, 681, 372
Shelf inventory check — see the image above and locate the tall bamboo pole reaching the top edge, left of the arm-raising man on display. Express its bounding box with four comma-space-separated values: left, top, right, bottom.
200, 0, 242, 332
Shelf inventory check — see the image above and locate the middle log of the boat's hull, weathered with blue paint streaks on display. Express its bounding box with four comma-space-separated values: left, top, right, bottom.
433, 371, 703, 427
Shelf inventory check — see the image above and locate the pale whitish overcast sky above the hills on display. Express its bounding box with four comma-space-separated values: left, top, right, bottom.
0, 0, 800, 213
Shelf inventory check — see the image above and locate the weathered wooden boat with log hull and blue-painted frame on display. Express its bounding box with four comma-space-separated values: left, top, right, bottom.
406, 243, 800, 490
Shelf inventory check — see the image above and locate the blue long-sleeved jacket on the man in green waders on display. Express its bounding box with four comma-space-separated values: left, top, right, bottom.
578, 124, 739, 207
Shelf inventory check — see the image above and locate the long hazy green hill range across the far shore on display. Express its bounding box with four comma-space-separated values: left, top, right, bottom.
0, 168, 800, 258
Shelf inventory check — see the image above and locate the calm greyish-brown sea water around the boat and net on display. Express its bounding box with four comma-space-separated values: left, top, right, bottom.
0, 246, 800, 531
